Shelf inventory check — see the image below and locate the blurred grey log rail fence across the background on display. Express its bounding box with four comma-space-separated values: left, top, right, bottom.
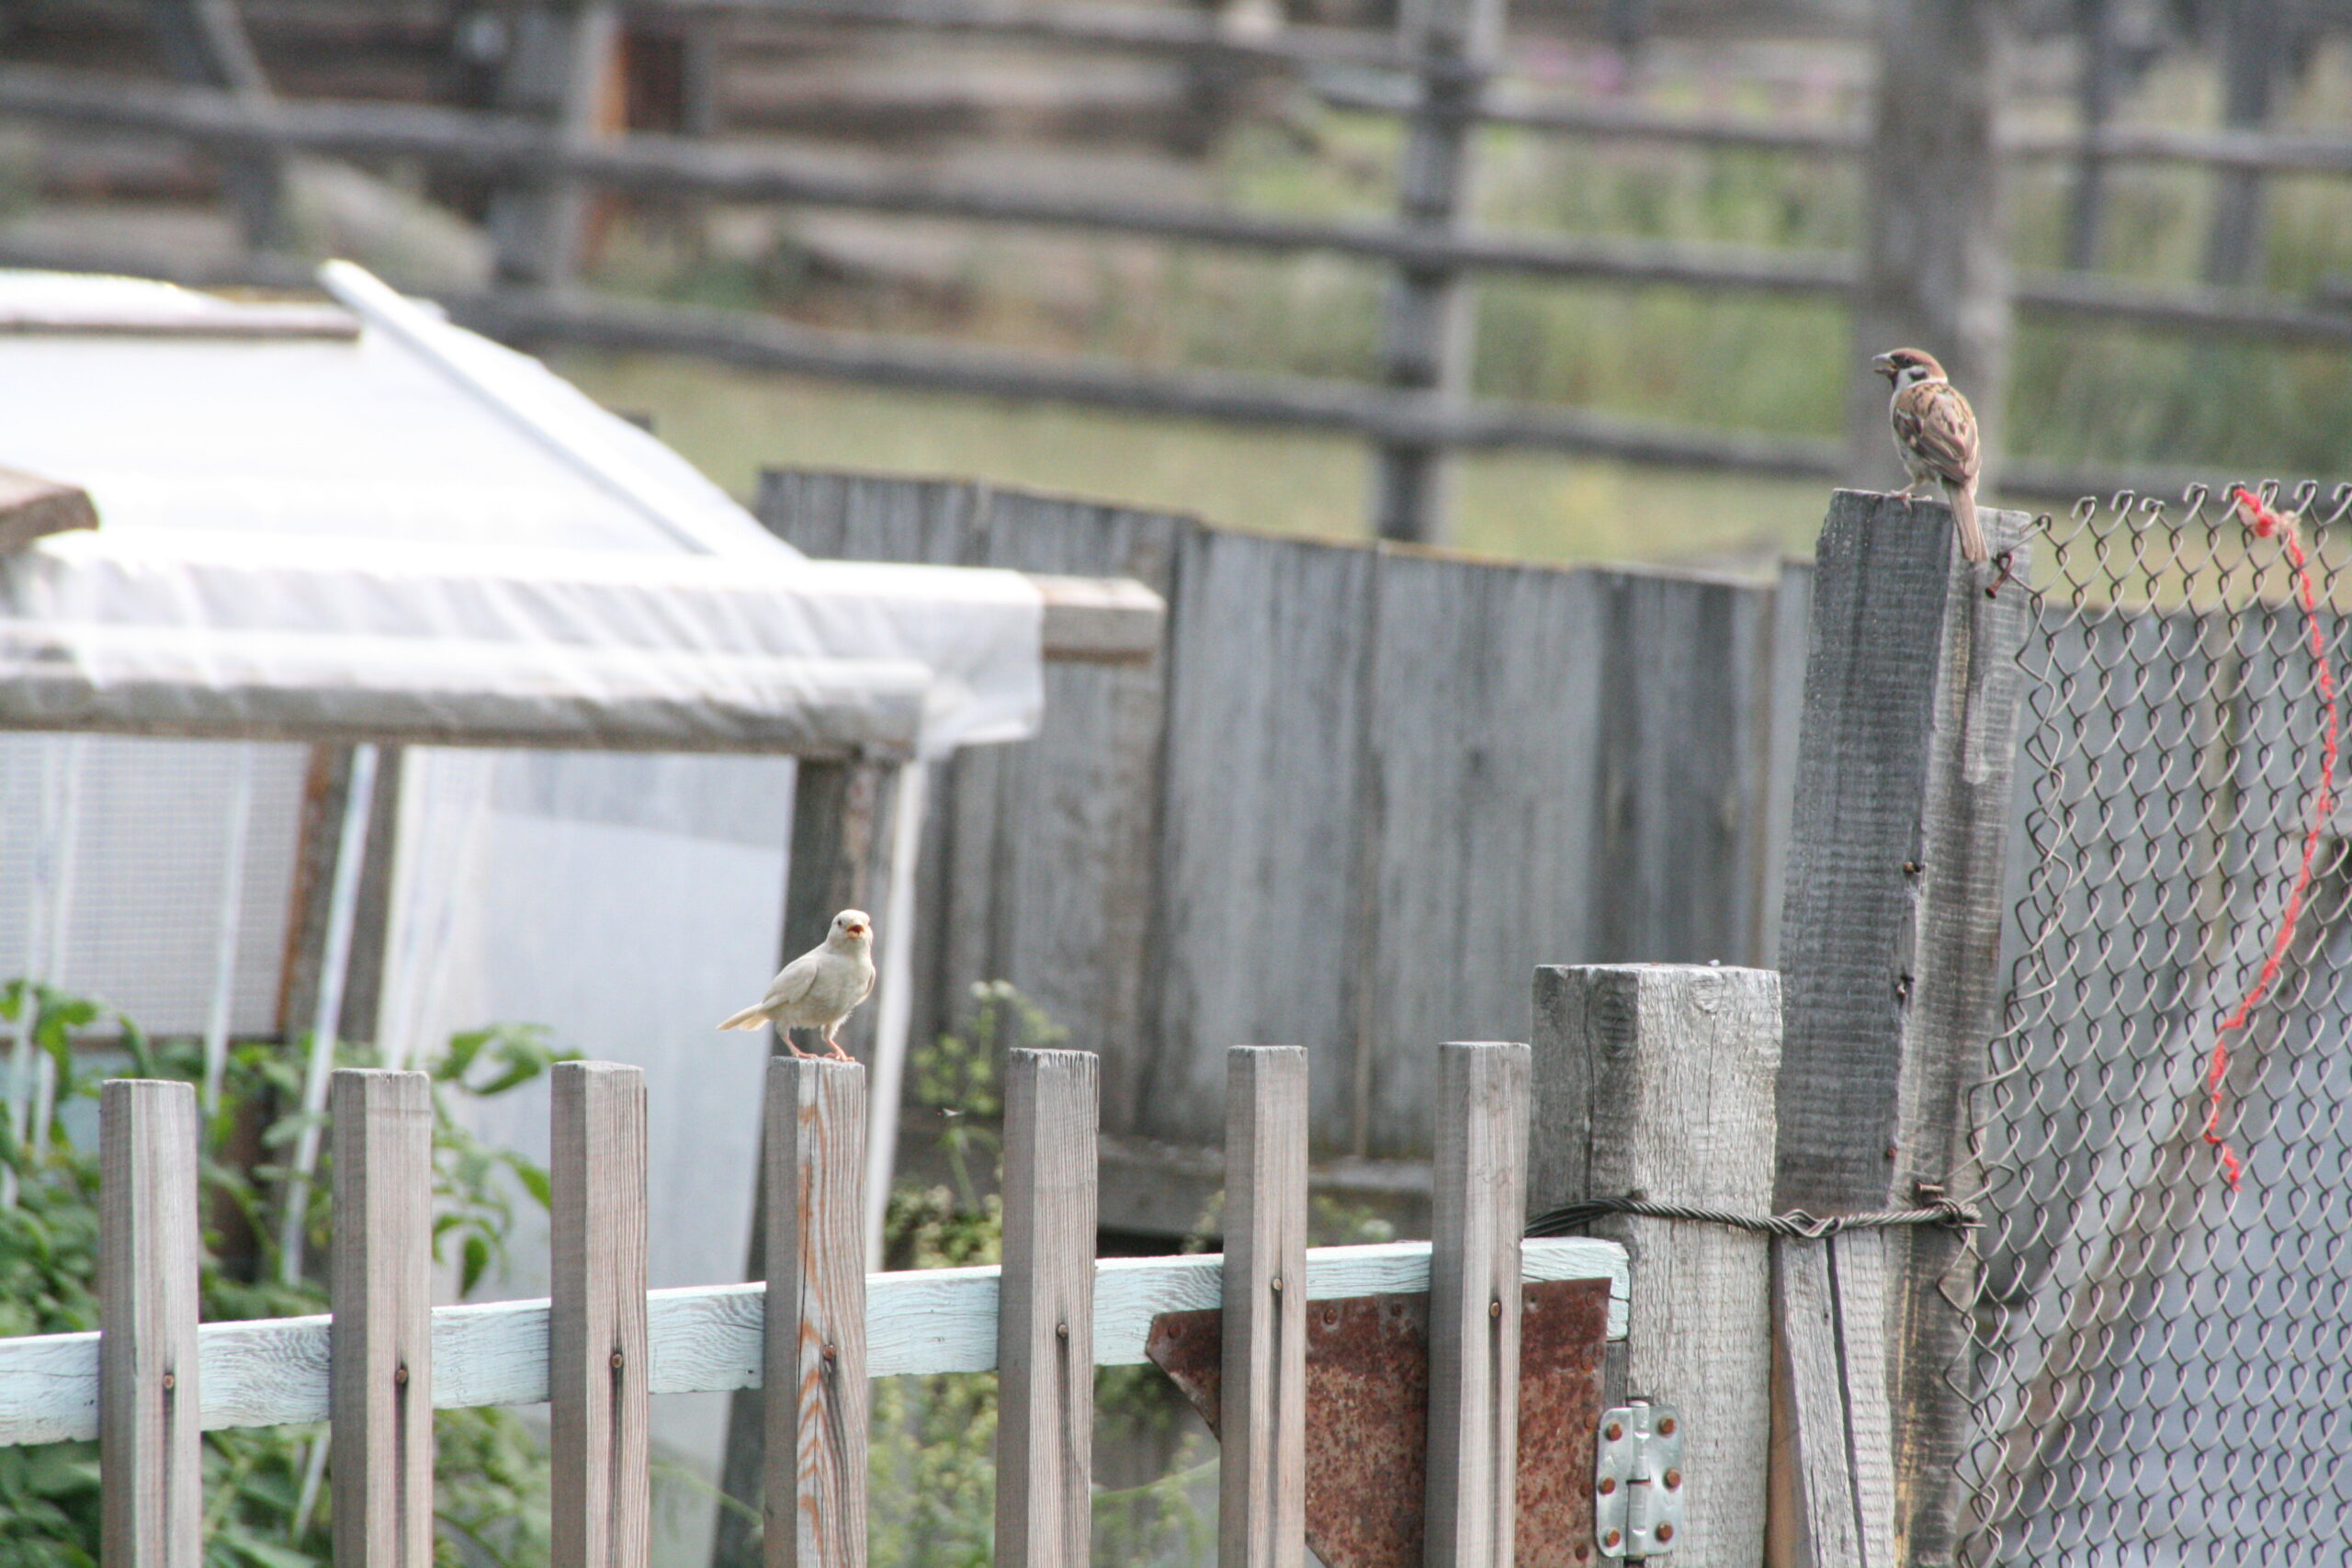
0, 0, 2352, 538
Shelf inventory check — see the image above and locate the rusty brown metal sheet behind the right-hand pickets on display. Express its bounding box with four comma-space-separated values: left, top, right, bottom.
1146, 1279, 1609, 1568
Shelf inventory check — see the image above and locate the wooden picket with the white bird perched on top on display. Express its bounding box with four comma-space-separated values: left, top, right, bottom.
762, 1055, 868, 1568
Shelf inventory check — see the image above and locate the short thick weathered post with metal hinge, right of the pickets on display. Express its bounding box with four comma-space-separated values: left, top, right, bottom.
1526, 964, 1781, 1563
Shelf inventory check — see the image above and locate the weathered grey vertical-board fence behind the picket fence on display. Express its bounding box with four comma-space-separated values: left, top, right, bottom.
760, 472, 1785, 1166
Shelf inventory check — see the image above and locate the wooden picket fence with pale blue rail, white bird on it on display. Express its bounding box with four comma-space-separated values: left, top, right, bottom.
0, 1043, 1628, 1568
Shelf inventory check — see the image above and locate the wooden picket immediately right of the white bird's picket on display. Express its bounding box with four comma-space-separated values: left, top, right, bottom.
997, 1051, 1099, 1568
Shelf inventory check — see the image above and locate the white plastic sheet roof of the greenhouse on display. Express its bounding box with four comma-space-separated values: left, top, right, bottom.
0, 264, 1042, 752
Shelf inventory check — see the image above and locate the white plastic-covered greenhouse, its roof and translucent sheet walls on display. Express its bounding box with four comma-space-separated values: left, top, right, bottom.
0, 265, 1042, 1504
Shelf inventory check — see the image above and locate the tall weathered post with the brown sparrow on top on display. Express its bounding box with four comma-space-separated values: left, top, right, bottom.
1773, 491, 2032, 1568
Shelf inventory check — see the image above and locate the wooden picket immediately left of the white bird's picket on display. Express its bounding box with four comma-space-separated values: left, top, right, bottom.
548, 1063, 651, 1568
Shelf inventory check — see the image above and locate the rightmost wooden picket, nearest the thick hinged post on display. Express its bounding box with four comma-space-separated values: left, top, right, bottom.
1423, 1043, 1529, 1568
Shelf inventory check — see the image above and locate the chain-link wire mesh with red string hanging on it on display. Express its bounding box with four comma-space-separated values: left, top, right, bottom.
1962, 489, 2352, 1568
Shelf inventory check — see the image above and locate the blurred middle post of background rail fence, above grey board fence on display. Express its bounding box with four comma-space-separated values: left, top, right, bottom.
1371, 0, 1503, 543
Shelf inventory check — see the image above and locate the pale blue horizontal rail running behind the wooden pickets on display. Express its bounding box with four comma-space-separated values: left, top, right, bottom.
0, 1239, 1630, 1446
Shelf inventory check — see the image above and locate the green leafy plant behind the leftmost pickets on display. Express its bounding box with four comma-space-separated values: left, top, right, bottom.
0, 980, 564, 1568
